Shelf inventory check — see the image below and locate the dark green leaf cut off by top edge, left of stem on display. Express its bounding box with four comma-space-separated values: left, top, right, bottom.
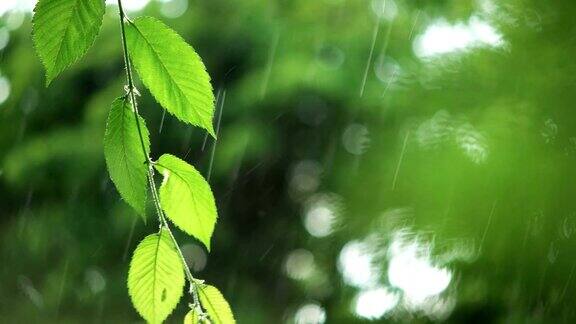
32, 0, 106, 85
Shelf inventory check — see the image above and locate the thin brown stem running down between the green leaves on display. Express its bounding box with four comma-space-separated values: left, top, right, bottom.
118, 0, 205, 315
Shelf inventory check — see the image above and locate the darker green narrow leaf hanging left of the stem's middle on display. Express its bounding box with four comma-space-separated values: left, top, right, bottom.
104, 97, 150, 218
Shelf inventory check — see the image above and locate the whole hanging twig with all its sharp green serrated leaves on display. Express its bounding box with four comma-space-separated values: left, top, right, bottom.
33, 0, 234, 323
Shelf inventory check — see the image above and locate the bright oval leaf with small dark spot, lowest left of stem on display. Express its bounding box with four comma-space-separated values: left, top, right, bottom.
128, 229, 184, 323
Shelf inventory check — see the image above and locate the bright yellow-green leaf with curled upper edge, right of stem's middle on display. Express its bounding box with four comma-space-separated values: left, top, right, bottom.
154, 154, 217, 250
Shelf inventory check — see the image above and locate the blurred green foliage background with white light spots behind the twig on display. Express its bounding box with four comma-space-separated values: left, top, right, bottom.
0, 0, 576, 323
